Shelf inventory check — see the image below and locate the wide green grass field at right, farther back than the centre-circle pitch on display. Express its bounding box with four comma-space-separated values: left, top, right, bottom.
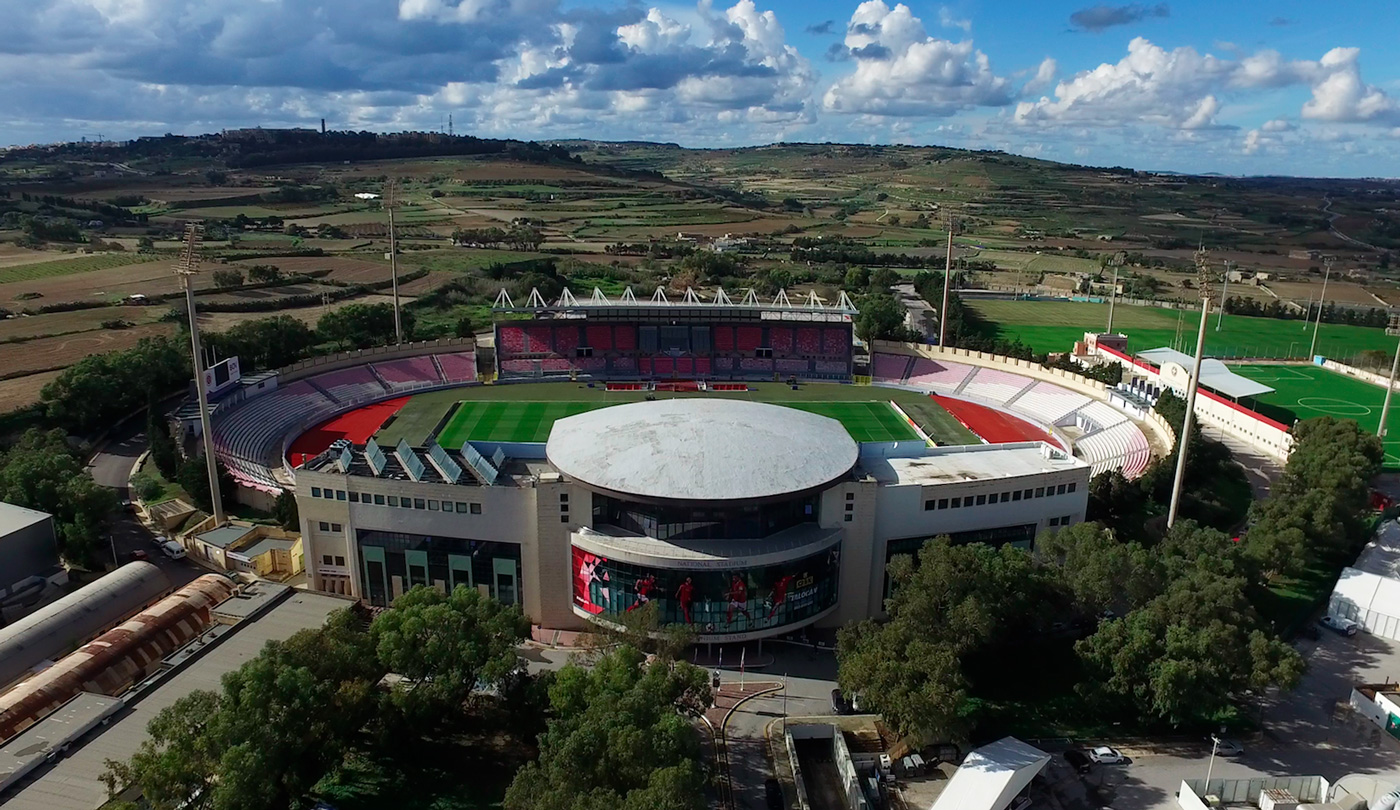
966, 301, 1394, 360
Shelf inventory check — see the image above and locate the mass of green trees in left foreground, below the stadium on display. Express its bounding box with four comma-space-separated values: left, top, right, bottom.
104, 586, 710, 810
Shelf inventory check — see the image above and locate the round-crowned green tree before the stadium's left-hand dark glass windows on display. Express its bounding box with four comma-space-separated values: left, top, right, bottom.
370, 585, 529, 720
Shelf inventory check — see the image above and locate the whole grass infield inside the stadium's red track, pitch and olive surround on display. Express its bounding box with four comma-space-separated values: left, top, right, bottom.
375, 382, 981, 448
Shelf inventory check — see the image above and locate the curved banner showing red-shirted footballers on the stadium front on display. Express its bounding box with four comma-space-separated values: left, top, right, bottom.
571, 546, 841, 635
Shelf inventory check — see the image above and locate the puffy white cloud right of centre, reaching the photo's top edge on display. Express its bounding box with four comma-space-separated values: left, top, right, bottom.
822, 0, 1011, 116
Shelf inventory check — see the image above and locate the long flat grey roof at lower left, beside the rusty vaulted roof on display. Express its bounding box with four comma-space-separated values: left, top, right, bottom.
0, 590, 350, 810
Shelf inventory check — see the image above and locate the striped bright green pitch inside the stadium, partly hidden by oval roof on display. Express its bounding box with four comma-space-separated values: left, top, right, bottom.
437, 400, 918, 448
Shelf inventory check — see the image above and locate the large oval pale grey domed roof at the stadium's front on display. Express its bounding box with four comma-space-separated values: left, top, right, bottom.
545, 399, 858, 501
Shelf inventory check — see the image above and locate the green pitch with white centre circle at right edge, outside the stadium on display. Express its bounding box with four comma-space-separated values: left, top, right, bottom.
1231, 365, 1400, 470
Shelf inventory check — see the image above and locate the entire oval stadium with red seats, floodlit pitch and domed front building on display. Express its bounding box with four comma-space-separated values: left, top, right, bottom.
194, 291, 1173, 641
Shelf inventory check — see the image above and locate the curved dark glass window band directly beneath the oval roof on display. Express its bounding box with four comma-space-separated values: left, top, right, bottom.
594, 494, 820, 540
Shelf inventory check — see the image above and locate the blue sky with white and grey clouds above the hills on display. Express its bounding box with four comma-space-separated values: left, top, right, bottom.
0, 0, 1400, 176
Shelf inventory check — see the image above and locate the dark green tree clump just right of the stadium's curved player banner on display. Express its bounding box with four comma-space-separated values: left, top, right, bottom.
836, 537, 1047, 740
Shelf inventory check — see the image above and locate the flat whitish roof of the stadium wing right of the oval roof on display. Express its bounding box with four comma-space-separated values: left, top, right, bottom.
861, 442, 1089, 487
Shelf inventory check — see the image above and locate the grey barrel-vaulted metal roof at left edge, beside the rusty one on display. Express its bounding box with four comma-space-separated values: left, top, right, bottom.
0, 562, 171, 687
